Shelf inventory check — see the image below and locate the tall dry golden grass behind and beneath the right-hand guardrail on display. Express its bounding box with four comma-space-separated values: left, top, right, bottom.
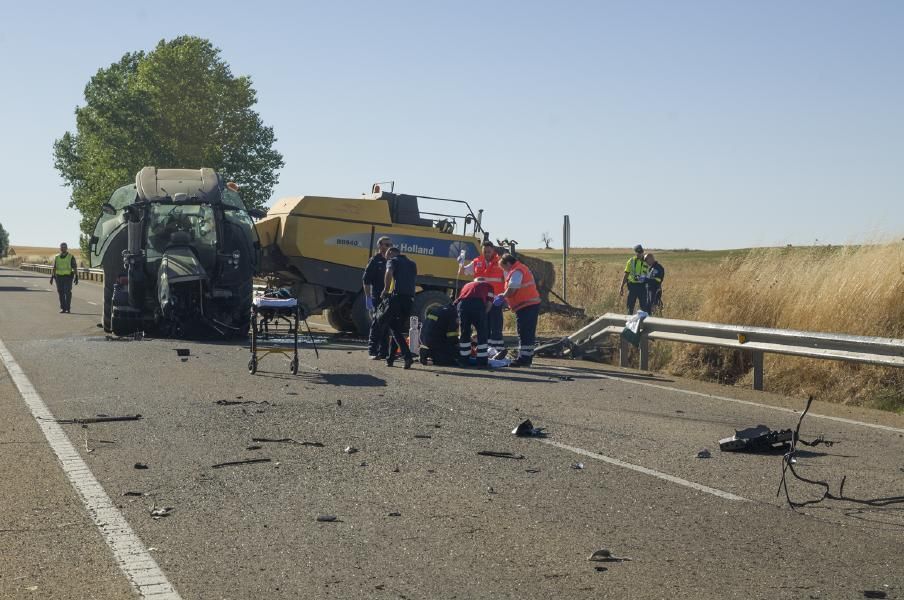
528, 241, 904, 412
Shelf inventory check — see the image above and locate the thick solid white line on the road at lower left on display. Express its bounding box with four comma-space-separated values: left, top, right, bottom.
0, 340, 181, 600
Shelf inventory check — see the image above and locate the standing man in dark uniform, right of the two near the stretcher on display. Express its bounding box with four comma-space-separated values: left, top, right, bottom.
380, 248, 417, 369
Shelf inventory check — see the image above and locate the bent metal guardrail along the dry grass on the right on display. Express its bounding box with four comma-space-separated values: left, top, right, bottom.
562, 313, 904, 390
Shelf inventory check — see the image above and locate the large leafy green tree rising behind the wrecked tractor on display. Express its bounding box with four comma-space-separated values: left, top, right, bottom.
53, 36, 284, 246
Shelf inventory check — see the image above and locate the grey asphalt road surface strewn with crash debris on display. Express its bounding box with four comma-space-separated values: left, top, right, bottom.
0, 270, 904, 600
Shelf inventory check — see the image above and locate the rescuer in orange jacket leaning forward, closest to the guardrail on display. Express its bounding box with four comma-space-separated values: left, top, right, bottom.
493, 254, 540, 367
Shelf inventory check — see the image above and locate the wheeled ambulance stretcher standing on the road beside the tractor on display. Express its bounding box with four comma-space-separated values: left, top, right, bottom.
248, 296, 299, 375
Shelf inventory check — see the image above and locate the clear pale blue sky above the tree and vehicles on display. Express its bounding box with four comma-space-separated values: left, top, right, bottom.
0, 0, 904, 249
